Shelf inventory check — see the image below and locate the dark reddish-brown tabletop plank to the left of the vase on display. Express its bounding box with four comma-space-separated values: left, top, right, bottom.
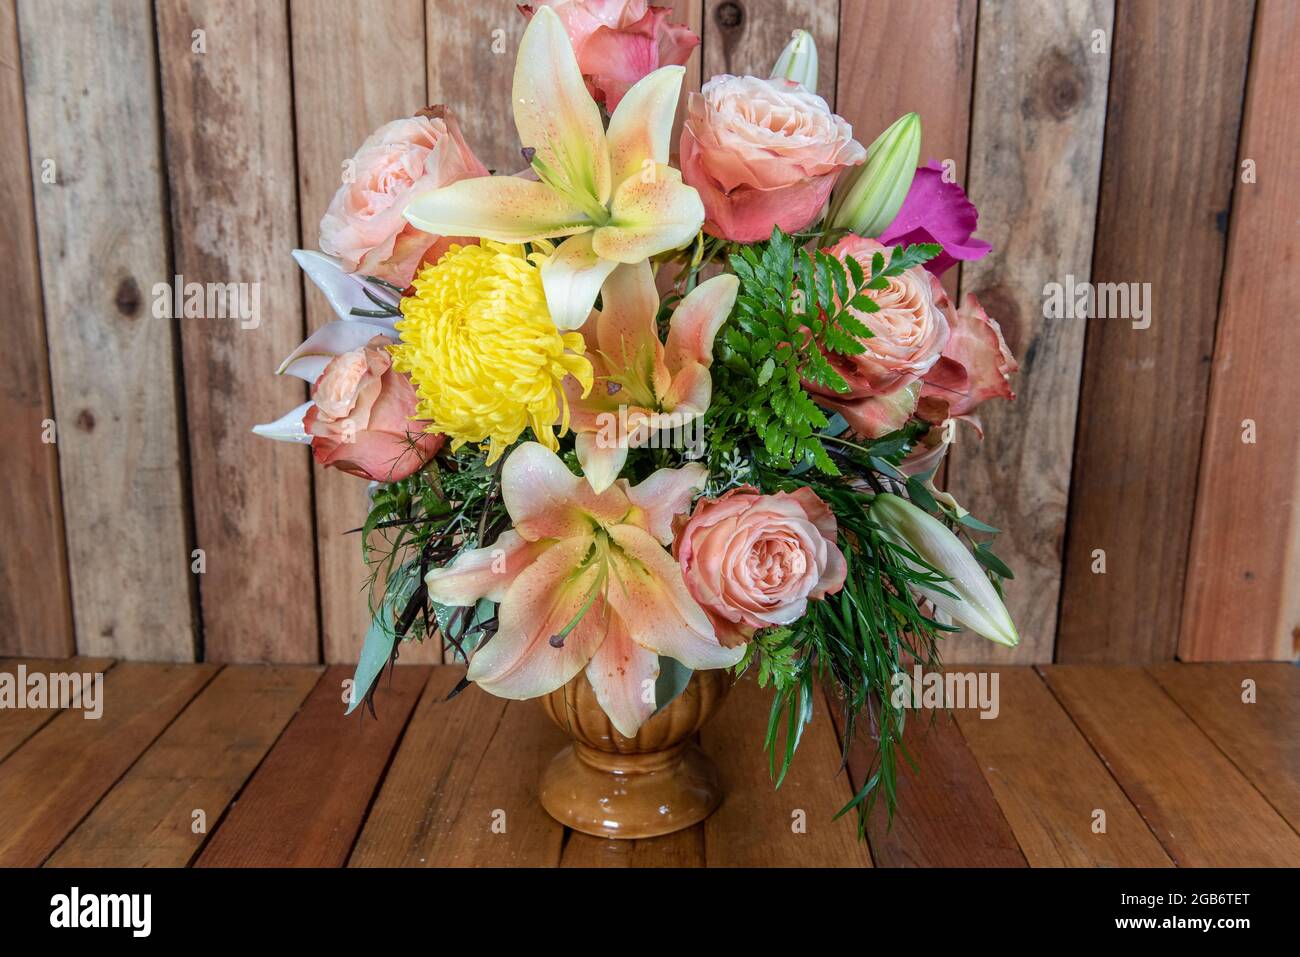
195, 664, 430, 867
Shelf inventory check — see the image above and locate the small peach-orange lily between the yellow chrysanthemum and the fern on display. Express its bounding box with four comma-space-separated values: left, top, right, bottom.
564, 260, 740, 493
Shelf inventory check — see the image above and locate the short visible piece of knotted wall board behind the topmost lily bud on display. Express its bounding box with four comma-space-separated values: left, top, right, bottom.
703, 0, 840, 102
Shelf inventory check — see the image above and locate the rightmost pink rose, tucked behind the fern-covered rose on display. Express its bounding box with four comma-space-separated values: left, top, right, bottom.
920, 294, 1021, 434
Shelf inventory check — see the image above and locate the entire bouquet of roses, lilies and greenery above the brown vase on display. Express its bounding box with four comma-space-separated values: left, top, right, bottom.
255, 0, 1019, 820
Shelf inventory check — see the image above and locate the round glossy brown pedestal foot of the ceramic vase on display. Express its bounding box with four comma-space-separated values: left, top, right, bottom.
541, 741, 722, 839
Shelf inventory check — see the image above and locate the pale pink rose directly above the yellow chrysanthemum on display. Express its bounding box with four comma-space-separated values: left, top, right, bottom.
320, 107, 488, 289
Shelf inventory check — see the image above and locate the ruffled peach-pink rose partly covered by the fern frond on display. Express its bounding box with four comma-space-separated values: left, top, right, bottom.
806, 234, 956, 438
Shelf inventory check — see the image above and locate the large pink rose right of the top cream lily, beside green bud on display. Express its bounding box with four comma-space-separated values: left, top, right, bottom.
681, 75, 867, 243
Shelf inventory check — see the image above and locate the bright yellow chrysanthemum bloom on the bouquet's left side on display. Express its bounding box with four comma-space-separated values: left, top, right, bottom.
393, 241, 592, 464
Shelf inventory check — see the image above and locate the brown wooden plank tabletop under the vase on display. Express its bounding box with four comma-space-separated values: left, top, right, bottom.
0, 658, 1300, 867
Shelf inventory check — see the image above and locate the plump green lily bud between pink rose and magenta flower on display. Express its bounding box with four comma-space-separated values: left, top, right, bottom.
827, 113, 920, 238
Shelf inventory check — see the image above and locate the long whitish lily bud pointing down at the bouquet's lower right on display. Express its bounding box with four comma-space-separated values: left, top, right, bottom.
870, 493, 1021, 648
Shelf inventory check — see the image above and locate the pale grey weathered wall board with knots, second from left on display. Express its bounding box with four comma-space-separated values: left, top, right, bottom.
18, 0, 195, 661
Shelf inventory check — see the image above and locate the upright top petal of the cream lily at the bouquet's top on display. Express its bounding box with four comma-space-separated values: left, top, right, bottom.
512, 7, 610, 206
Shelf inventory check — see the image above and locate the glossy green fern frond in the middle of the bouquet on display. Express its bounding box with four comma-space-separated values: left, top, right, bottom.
707, 229, 940, 475
